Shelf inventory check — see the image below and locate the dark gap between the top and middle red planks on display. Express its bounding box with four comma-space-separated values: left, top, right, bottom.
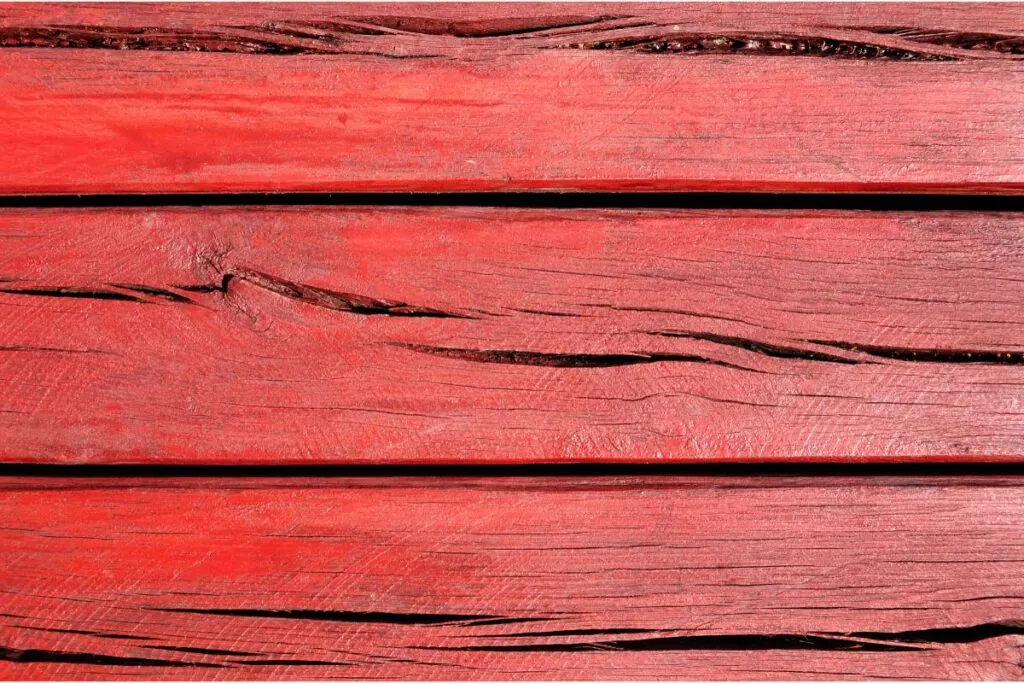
6, 191, 1024, 211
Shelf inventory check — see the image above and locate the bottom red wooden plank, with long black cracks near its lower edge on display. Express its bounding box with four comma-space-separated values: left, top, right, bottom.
0, 478, 1024, 680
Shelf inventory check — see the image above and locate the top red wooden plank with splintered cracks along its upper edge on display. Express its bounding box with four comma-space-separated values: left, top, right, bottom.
0, 3, 1024, 194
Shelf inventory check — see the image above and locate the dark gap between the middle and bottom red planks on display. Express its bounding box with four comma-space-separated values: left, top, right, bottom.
0, 462, 1024, 479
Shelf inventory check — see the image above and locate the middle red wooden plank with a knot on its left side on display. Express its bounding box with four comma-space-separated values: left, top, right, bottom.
0, 207, 1024, 464
